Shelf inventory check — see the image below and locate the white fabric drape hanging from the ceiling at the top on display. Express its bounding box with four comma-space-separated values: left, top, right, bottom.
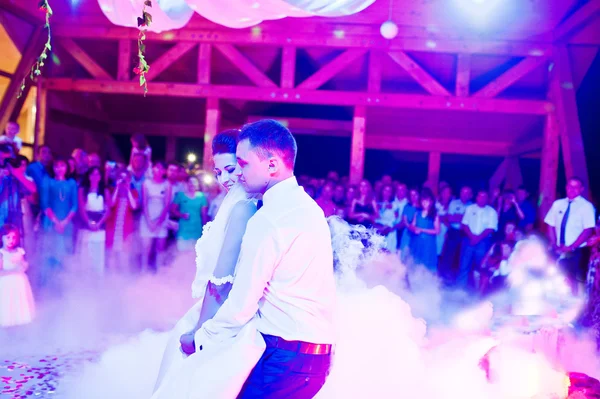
98, 0, 375, 33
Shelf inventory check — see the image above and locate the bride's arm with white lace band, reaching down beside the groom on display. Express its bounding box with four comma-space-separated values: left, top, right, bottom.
188, 201, 256, 332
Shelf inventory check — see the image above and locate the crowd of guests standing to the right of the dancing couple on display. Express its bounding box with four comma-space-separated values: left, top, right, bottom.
300, 167, 600, 296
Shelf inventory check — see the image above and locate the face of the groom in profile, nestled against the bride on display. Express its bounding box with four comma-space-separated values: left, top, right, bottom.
236, 140, 270, 193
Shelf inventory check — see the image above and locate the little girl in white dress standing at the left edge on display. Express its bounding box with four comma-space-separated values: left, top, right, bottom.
0, 225, 35, 327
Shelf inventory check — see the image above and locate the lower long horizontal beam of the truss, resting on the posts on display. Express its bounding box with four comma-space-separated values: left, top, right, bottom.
45, 78, 553, 115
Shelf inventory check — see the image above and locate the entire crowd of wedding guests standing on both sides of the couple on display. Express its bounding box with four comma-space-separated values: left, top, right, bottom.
0, 123, 600, 326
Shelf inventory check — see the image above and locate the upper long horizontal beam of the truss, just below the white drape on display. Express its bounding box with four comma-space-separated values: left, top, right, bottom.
53, 25, 552, 57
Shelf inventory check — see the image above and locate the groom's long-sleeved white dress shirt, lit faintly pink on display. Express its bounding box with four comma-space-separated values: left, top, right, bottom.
196, 177, 336, 346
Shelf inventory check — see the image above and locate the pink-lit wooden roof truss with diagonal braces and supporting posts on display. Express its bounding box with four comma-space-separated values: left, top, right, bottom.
0, 0, 600, 203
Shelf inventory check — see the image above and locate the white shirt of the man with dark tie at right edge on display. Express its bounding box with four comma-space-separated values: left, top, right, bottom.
544, 196, 596, 247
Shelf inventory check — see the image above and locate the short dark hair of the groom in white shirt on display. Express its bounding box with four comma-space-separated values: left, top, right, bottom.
239, 119, 298, 170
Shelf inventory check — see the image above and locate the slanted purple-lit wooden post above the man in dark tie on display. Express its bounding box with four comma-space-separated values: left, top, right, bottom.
550, 46, 589, 188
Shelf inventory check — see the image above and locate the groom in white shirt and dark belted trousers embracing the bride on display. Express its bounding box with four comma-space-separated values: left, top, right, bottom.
195, 120, 335, 399
